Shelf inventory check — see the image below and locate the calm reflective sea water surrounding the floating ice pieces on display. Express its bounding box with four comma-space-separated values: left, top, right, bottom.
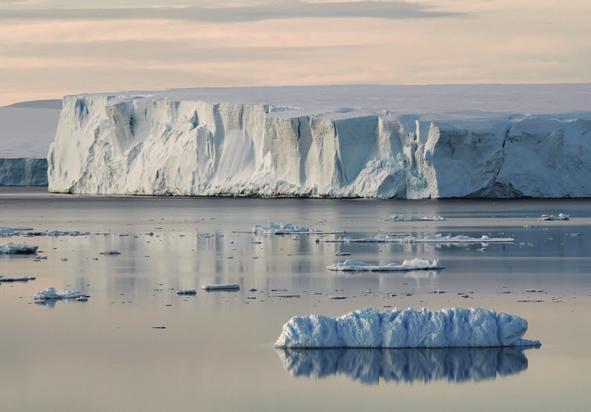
0, 189, 591, 411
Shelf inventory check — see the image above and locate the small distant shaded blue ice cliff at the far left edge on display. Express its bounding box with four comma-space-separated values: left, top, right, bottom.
0, 158, 47, 186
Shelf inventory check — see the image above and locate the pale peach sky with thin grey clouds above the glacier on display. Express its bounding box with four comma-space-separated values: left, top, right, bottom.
0, 0, 591, 105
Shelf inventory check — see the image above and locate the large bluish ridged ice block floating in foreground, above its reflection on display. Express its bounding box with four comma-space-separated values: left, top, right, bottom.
275, 308, 540, 348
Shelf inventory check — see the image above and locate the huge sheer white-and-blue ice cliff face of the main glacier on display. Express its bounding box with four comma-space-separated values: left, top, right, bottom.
48, 95, 591, 199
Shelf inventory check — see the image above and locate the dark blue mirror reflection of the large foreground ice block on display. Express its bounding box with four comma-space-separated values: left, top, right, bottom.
277, 347, 527, 384
